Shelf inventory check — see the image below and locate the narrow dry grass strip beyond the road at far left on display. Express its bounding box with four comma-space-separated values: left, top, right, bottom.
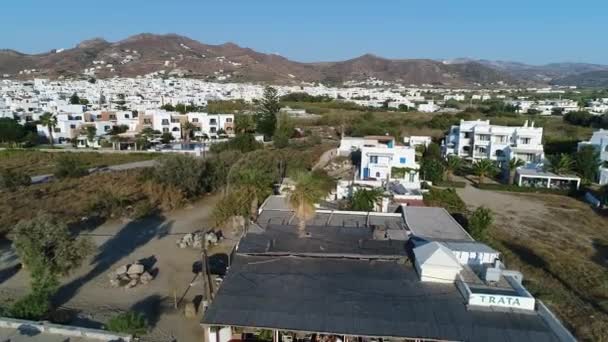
0, 150, 158, 176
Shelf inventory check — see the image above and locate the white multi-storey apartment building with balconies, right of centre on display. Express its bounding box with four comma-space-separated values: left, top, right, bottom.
442, 120, 544, 167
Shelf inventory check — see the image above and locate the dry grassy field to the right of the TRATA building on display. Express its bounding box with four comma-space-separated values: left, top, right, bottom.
484, 194, 608, 341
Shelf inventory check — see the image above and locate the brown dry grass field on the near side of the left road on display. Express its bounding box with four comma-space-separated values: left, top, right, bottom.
0, 169, 186, 235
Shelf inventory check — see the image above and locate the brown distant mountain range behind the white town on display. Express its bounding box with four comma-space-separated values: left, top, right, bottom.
0, 34, 608, 87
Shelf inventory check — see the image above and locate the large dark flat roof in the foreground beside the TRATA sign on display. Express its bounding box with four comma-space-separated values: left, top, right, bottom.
202, 255, 558, 342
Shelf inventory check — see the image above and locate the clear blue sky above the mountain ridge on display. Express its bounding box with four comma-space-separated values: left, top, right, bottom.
0, 0, 608, 64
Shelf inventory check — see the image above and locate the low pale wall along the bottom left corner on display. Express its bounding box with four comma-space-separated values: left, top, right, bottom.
0, 317, 133, 342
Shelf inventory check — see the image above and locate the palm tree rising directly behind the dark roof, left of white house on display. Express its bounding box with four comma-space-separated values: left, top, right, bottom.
287, 173, 325, 237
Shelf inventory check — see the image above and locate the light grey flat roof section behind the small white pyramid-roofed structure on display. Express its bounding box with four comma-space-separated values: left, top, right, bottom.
403, 206, 474, 241
